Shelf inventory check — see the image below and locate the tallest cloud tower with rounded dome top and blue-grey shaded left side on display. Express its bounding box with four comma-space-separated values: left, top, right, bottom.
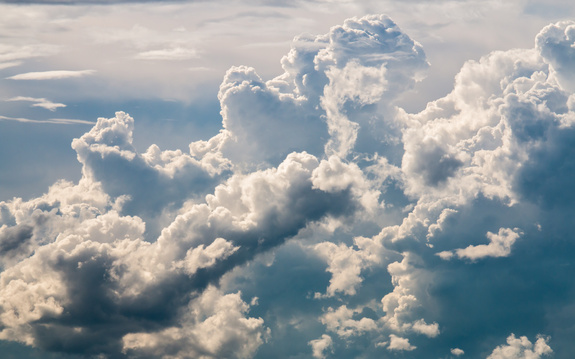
212, 15, 428, 163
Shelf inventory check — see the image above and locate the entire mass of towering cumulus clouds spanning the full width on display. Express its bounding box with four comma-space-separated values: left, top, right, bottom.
0, 15, 575, 358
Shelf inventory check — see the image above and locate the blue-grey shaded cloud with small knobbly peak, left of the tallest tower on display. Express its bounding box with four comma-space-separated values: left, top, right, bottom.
72, 112, 229, 219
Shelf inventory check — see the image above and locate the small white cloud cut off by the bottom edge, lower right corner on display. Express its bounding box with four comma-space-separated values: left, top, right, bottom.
487, 334, 553, 359
